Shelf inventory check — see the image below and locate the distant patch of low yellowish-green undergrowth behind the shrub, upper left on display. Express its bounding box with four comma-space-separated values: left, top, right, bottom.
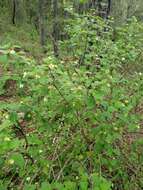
0, 15, 44, 58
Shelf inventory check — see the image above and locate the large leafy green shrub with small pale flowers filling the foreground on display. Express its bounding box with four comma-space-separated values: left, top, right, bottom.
0, 17, 143, 190
